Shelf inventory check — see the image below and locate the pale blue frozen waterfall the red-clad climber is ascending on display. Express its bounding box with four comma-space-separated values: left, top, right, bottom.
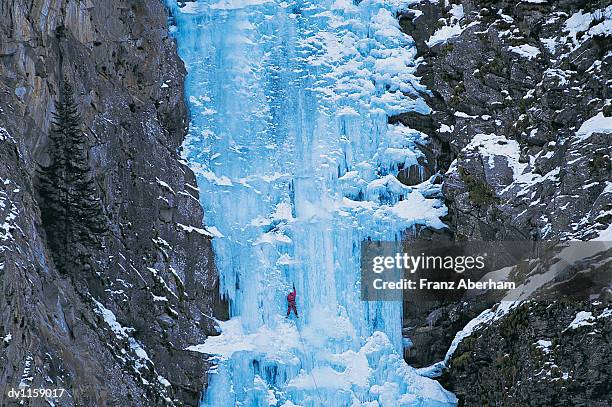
168, 0, 455, 406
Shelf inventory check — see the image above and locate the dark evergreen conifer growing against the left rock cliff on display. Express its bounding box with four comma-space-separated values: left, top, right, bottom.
39, 81, 107, 272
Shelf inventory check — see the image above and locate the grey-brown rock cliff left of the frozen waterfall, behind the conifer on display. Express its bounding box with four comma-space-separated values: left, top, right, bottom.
0, 0, 224, 406
